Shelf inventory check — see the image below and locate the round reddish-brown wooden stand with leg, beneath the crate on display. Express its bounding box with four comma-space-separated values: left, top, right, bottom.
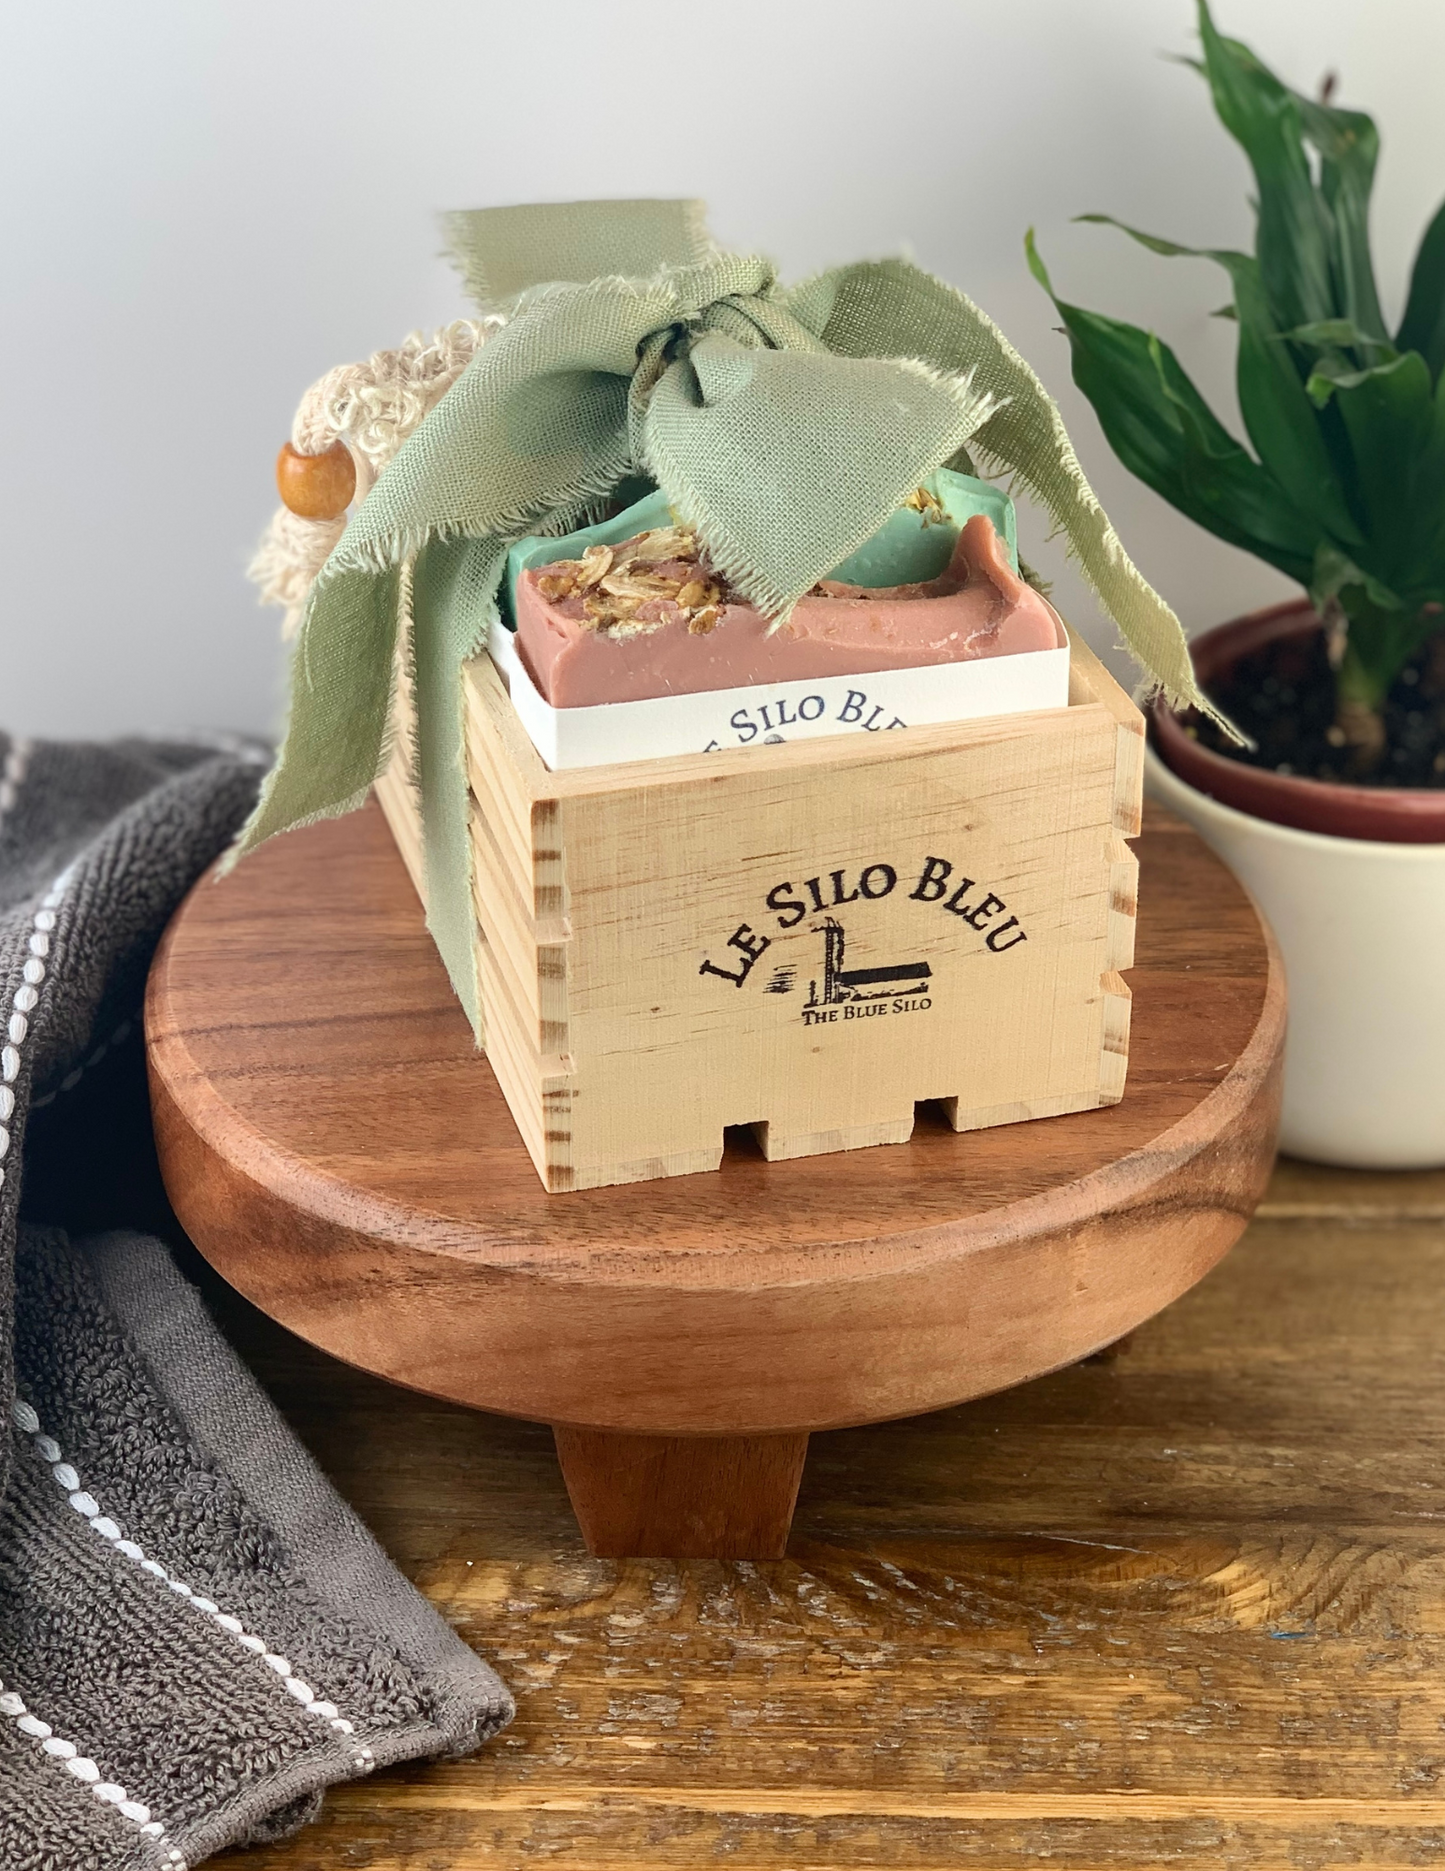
146, 805, 1284, 1559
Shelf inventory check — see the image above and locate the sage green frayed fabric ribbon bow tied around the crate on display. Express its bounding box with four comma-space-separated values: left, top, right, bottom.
236, 202, 1207, 1038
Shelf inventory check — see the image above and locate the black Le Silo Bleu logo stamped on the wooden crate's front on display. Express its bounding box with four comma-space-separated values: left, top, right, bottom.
698, 855, 1028, 1025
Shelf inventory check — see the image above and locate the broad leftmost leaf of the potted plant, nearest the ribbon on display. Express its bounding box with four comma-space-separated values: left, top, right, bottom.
1028, 243, 1318, 584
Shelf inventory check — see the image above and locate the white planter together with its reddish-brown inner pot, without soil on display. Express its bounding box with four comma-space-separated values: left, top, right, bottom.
1147, 602, 1445, 1169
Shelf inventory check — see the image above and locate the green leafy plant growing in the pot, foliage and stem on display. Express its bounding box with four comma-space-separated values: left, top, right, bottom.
1026, 0, 1445, 763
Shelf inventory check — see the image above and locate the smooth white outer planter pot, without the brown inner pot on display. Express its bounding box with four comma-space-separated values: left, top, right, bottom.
1144, 748, 1445, 1169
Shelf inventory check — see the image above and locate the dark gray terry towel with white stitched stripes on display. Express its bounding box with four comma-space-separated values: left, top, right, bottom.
0, 735, 511, 1871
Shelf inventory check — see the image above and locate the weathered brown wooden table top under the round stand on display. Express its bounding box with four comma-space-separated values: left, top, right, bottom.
205, 1164, 1445, 1871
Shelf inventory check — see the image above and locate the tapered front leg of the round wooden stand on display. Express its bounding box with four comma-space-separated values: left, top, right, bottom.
552, 1426, 809, 1559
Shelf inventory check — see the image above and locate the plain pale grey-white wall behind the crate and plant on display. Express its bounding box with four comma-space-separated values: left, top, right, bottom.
0, 0, 1445, 735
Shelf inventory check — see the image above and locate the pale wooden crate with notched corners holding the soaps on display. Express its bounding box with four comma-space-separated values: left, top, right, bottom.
376, 638, 1144, 1192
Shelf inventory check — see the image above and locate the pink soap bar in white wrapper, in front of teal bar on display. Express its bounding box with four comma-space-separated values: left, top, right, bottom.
517, 515, 1067, 707
